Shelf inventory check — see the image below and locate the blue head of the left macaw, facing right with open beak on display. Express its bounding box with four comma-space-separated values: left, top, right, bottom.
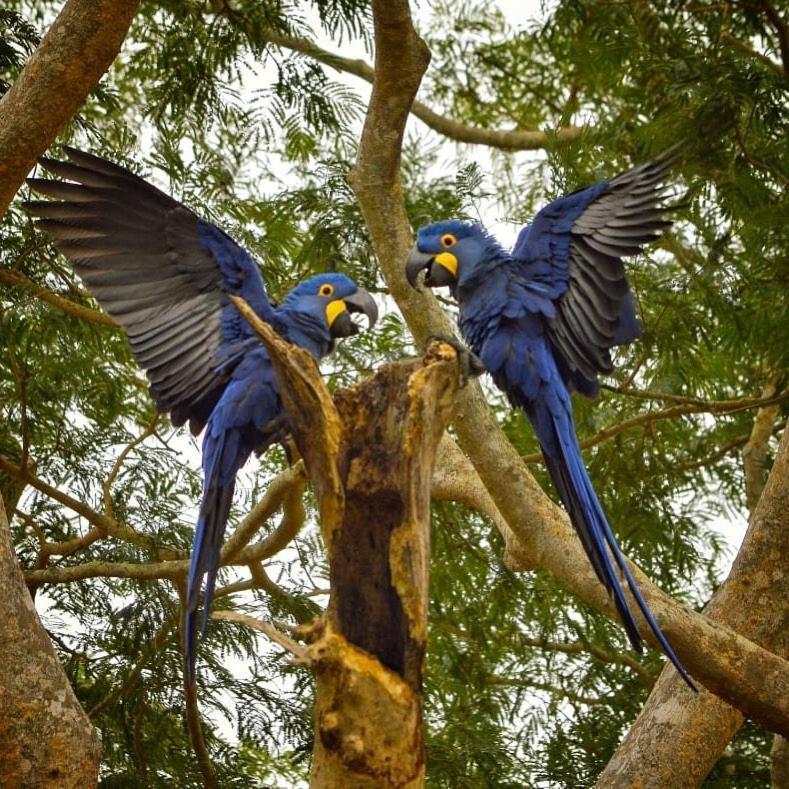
280, 274, 378, 339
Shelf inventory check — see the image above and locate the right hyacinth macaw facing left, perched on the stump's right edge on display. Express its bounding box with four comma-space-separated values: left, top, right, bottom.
406, 151, 695, 689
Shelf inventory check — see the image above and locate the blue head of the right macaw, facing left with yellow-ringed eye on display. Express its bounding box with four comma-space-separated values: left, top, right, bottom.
405, 219, 501, 292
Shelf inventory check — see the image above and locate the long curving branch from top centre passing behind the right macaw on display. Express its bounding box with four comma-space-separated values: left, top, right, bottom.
350, 0, 789, 732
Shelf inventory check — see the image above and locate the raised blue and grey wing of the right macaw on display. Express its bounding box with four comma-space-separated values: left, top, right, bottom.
512, 147, 677, 396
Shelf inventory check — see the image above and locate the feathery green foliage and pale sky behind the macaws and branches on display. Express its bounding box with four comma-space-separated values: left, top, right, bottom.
0, 0, 789, 787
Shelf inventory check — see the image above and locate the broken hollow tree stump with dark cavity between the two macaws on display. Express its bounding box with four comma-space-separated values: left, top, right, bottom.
234, 299, 458, 789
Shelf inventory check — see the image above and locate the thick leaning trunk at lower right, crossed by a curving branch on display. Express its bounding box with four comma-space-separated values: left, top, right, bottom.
597, 419, 789, 789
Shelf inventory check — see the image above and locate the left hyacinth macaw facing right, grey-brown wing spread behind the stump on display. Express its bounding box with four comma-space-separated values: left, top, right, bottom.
25, 148, 378, 681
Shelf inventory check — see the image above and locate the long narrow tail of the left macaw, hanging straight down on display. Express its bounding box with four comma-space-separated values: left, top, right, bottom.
184, 426, 239, 683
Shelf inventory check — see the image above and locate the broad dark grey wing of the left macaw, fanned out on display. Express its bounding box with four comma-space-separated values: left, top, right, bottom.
25, 148, 275, 434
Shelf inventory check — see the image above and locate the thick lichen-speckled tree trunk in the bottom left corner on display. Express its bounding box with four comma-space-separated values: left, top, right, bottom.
0, 492, 101, 789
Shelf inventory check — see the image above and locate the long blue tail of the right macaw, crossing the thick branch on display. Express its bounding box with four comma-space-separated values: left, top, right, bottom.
527, 401, 697, 691
